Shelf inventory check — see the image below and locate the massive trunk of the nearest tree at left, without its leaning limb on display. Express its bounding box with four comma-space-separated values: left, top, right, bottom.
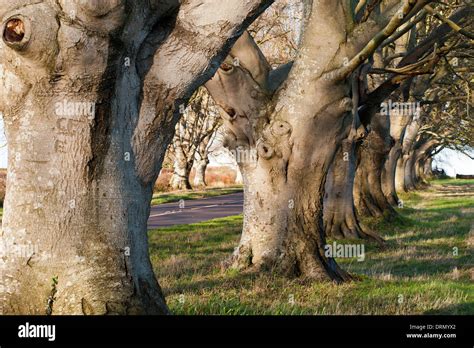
0, 3, 167, 314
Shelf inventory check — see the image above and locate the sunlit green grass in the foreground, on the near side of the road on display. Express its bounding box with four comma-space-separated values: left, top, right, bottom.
150, 180, 474, 315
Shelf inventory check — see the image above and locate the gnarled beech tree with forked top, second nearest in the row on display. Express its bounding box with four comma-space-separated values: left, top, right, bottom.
206, 1, 450, 281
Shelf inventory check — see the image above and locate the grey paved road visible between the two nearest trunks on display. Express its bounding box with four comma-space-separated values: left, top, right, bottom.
148, 192, 244, 229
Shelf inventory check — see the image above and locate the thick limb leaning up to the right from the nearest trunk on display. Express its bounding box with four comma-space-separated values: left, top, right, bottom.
132, 0, 273, 183
